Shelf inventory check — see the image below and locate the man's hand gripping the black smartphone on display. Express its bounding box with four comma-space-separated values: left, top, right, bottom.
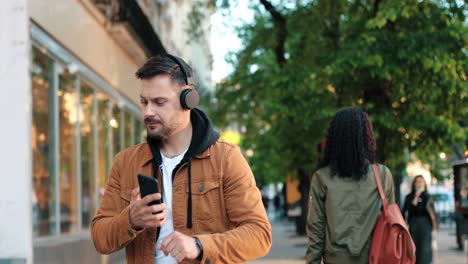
129, 188, 166, 229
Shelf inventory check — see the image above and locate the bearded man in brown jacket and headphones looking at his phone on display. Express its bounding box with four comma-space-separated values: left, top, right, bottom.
91, 55, 271, 264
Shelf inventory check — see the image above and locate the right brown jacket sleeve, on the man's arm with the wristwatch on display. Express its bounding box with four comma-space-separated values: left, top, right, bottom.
197, 147, 272, 263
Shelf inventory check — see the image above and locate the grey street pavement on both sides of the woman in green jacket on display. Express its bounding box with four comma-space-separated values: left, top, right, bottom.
248, 221, 468, 264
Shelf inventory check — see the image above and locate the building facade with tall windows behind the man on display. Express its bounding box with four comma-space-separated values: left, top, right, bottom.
0, 0, 211, 263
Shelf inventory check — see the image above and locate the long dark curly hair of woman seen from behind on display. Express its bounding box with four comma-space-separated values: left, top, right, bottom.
319, 108, 376, 180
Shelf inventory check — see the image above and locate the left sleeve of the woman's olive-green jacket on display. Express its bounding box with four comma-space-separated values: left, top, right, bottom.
306, 172, 326, 264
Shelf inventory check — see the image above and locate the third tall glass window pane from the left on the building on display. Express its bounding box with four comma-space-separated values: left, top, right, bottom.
79, 82, 95, 228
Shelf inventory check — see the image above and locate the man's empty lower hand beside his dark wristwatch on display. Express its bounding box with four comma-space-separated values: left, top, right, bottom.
157, 231, 200, 262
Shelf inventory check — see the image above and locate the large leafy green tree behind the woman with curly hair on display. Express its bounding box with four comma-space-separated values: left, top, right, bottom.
211, 0, 468, 233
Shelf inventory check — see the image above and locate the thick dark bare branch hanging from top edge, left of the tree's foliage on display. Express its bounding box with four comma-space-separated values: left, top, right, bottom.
260, 0, 288, 67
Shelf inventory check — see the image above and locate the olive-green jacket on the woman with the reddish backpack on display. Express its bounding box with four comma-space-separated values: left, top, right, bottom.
306, 164, 395, 264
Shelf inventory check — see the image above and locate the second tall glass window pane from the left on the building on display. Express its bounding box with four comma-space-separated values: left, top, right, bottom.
58, 70, 78, 233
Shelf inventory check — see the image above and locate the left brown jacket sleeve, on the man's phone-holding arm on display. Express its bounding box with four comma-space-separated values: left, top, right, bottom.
91, 154, 143, 254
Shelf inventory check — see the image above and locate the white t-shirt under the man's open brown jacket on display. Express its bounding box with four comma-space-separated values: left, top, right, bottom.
154, 150, 187, 264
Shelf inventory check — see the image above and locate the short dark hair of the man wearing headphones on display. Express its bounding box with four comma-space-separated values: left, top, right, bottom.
135, 55, 193, 86
